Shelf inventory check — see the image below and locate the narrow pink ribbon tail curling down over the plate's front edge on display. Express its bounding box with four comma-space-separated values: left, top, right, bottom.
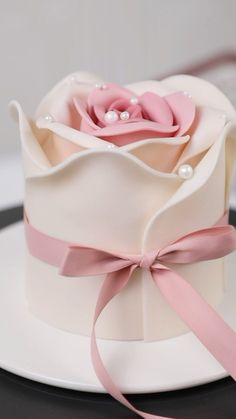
91, 265, 173, 419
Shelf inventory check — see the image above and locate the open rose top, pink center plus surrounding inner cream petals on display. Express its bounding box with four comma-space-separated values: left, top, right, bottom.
26, 73, 230, 173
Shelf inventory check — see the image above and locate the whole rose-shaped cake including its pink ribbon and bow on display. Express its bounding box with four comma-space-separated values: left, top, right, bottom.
11, 73, 236, 417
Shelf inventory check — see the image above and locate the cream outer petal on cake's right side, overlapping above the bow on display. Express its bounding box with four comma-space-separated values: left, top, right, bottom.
144, 122, 236, 250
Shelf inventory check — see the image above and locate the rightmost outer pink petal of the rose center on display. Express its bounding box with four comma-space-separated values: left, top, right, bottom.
165, 92, 195, 136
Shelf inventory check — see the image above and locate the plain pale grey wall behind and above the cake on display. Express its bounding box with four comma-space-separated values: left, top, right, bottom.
0, 0, 236, 153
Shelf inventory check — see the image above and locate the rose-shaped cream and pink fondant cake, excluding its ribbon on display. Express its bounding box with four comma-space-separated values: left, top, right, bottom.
12, 73, 236, 341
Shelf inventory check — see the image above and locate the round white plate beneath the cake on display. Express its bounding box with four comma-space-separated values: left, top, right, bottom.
0, 223, 236, 393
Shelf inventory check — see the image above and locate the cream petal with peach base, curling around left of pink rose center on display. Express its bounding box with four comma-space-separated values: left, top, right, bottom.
35, 73, 109, 165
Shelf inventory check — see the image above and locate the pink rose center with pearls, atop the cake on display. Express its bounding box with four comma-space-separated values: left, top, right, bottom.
74, 84, 195, 146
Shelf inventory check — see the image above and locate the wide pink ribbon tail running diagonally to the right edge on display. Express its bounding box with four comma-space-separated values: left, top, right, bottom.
152, 266, 236, 381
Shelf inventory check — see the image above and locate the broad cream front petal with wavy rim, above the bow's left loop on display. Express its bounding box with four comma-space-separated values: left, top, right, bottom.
26, 150, 182, 253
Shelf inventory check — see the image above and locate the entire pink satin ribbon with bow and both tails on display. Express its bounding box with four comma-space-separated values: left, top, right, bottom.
25, 218, 236, 419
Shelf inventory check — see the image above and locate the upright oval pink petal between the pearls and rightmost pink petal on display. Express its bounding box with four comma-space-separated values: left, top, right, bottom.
139, 92, 174, 126
